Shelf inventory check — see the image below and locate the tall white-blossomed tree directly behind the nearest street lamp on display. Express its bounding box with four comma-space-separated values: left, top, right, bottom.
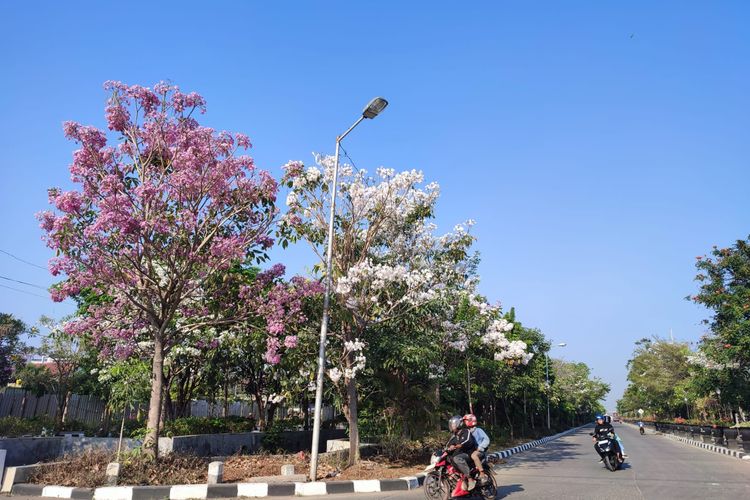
281, 157, 482, 463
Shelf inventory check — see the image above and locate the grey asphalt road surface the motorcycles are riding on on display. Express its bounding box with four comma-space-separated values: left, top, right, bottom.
268, 425, 750, 500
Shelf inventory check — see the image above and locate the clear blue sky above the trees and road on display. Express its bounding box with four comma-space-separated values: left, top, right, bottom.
0, 1, 750, 407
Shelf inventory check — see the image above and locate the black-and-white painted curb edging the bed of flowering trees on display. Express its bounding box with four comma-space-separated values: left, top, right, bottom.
11, 424, 589, 500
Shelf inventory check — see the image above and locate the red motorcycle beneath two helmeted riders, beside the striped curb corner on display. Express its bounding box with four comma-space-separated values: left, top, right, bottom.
423, 450, 497, 500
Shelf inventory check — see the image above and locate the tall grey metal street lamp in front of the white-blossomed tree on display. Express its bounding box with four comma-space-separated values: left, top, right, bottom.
310, 97, 388, 481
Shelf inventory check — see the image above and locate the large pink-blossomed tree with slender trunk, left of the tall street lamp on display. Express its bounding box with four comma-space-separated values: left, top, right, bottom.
38, 82, 277, 453
